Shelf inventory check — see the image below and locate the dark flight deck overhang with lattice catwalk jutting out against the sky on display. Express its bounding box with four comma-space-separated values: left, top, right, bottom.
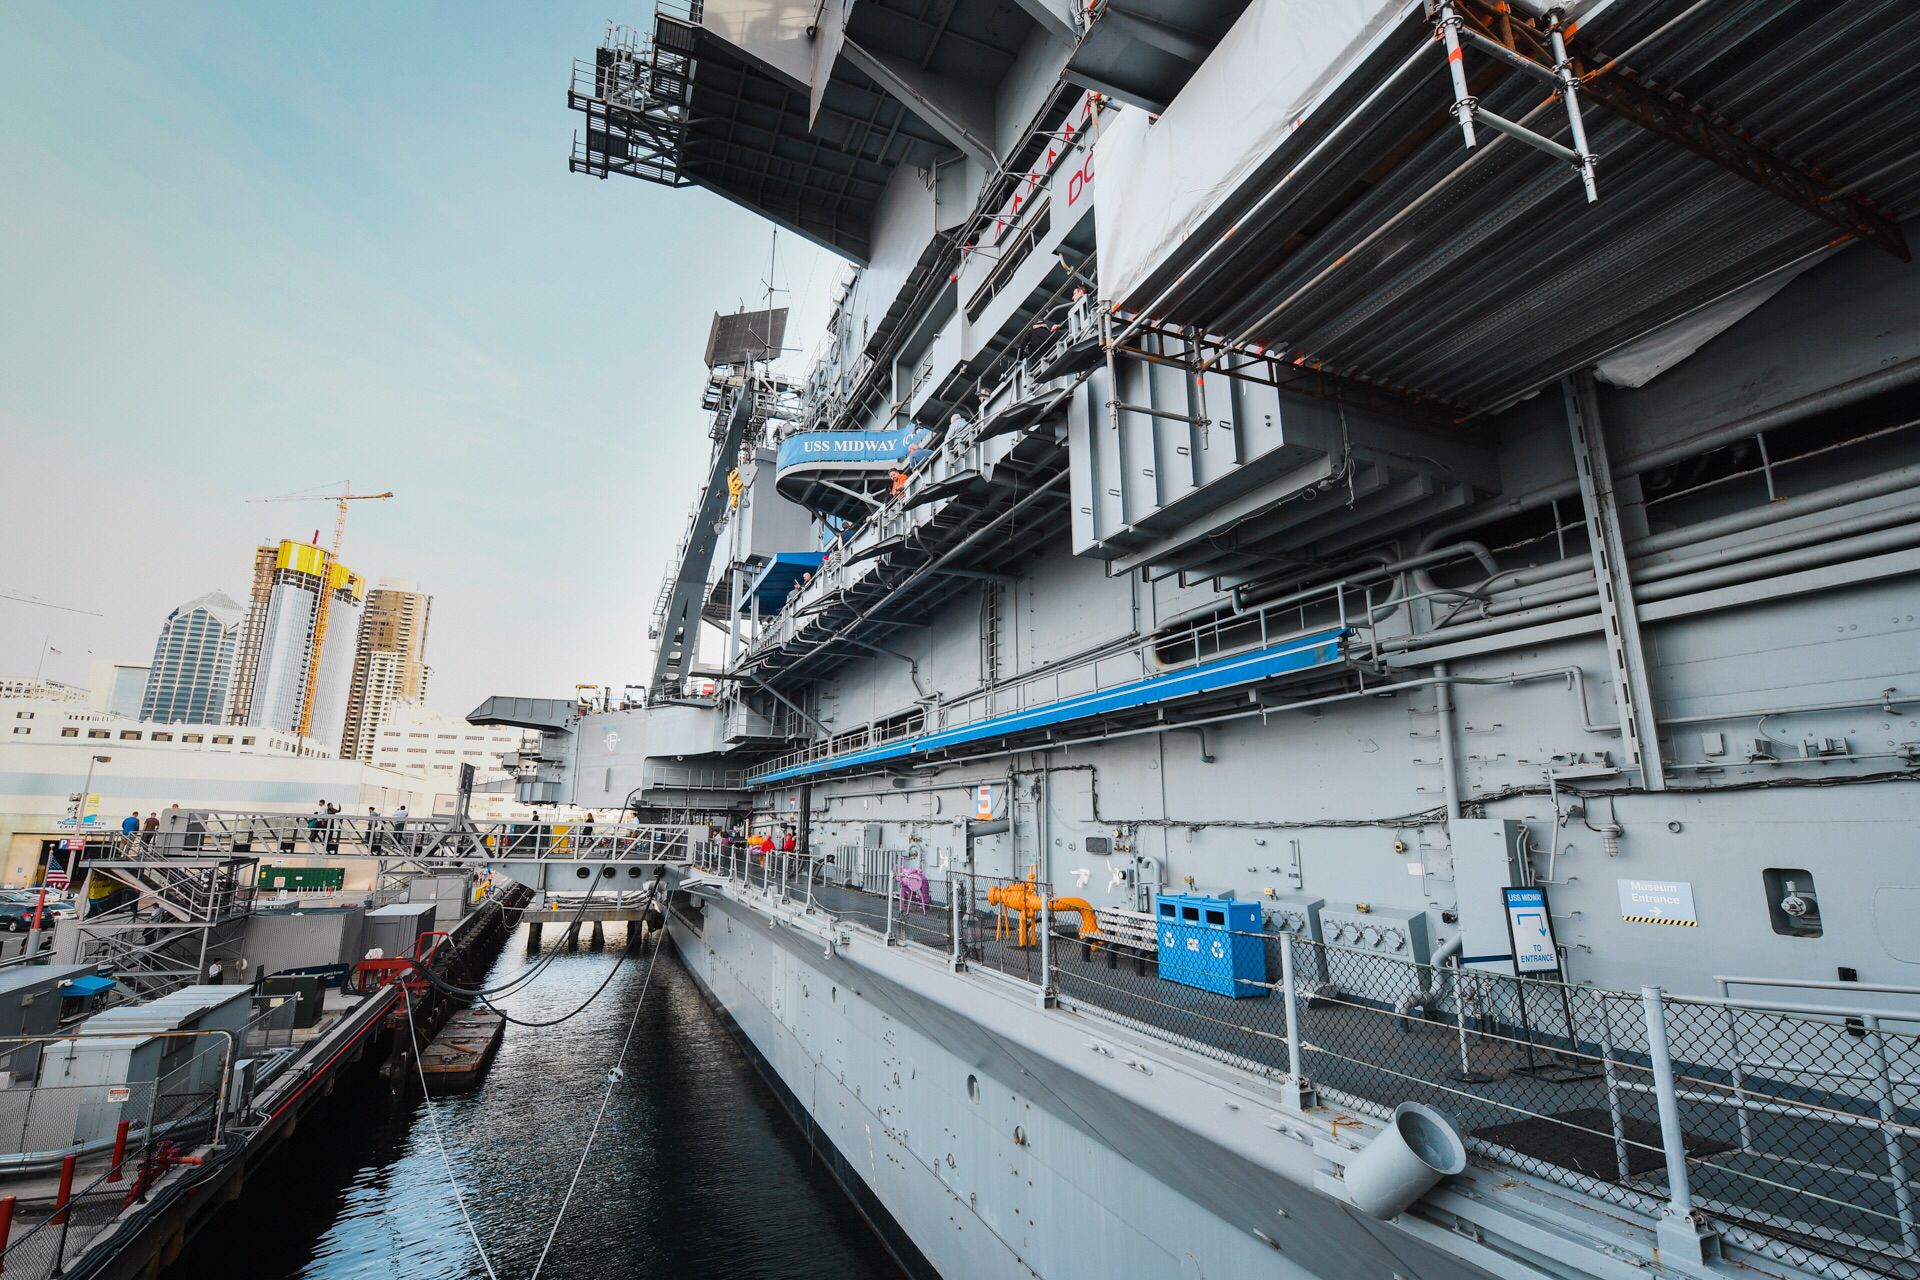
568, 0, 1246, 263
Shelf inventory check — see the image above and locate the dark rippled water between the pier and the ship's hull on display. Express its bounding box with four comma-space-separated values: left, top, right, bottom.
167, 925, 899, 1280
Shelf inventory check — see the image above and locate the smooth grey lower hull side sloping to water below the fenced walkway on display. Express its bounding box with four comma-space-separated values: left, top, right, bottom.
668, 890, 1647, 1280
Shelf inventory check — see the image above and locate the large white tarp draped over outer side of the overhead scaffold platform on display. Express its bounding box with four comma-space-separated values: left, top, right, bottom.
1094, 0, 1420, 305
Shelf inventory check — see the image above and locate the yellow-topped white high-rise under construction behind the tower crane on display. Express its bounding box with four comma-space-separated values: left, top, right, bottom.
227, 541, 367, 747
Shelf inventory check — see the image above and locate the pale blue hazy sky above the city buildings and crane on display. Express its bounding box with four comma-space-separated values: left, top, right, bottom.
0, 0, 845, 714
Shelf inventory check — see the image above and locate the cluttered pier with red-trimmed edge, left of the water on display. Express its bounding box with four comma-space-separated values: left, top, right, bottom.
0, 887, 526, 1280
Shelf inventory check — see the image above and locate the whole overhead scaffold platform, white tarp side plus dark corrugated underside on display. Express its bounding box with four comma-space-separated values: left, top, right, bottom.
1098, 0, 1920, 413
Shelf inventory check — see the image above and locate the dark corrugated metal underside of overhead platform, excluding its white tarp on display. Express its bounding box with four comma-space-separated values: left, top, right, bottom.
1117, 0, 1920, 411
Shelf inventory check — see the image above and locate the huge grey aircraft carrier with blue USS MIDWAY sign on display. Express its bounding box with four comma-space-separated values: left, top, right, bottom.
487, 0, 1920, 1280
